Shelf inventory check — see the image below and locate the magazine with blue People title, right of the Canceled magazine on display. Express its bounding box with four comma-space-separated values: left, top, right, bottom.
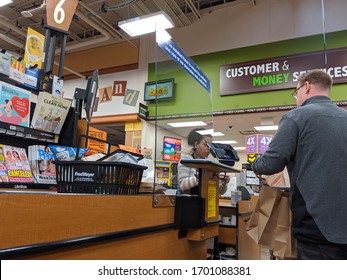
28, 145, 57, 184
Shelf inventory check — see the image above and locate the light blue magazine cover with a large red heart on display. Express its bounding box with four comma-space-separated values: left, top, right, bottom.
0, 81, 31, 127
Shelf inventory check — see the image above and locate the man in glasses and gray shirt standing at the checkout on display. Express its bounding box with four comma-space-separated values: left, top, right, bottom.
252, 70, 347, 259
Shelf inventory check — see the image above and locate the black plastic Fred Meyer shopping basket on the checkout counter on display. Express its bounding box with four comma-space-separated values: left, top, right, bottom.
54, 135, 147, 195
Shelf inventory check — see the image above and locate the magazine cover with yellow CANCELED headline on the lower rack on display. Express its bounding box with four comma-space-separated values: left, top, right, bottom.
2, 145, 34, 183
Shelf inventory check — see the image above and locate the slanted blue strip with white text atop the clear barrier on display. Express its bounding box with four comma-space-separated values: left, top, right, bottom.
158, 39, 211, 93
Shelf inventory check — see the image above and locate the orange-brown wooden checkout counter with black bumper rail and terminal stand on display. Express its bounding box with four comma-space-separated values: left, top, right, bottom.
0, 160, 258, 260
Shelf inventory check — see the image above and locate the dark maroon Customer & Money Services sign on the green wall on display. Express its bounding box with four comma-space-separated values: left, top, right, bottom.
219, 48, 347, 96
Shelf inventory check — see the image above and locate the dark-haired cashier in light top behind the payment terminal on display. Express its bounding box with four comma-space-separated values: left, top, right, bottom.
177, 128, 230, 195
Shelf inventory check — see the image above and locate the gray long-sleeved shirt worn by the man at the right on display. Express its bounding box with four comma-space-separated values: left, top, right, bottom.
253, 96, 347, 244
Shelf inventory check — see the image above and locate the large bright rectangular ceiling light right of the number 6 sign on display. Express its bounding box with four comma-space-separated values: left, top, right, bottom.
118, 11, 174, 37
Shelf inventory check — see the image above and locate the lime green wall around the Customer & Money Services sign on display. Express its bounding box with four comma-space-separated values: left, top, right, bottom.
147, 30, 347, 116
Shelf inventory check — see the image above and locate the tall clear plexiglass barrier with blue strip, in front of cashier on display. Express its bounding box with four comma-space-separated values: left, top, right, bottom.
150, 29, 213, 207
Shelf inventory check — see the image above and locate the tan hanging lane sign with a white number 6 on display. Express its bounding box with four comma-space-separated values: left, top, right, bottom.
46, 0, 78, 32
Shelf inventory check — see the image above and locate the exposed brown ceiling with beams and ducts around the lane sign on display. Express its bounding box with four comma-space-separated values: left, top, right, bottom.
0, 0, 247, 54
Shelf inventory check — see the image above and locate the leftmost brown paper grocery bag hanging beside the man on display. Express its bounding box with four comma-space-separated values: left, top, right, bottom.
246, 186, 282, 249
